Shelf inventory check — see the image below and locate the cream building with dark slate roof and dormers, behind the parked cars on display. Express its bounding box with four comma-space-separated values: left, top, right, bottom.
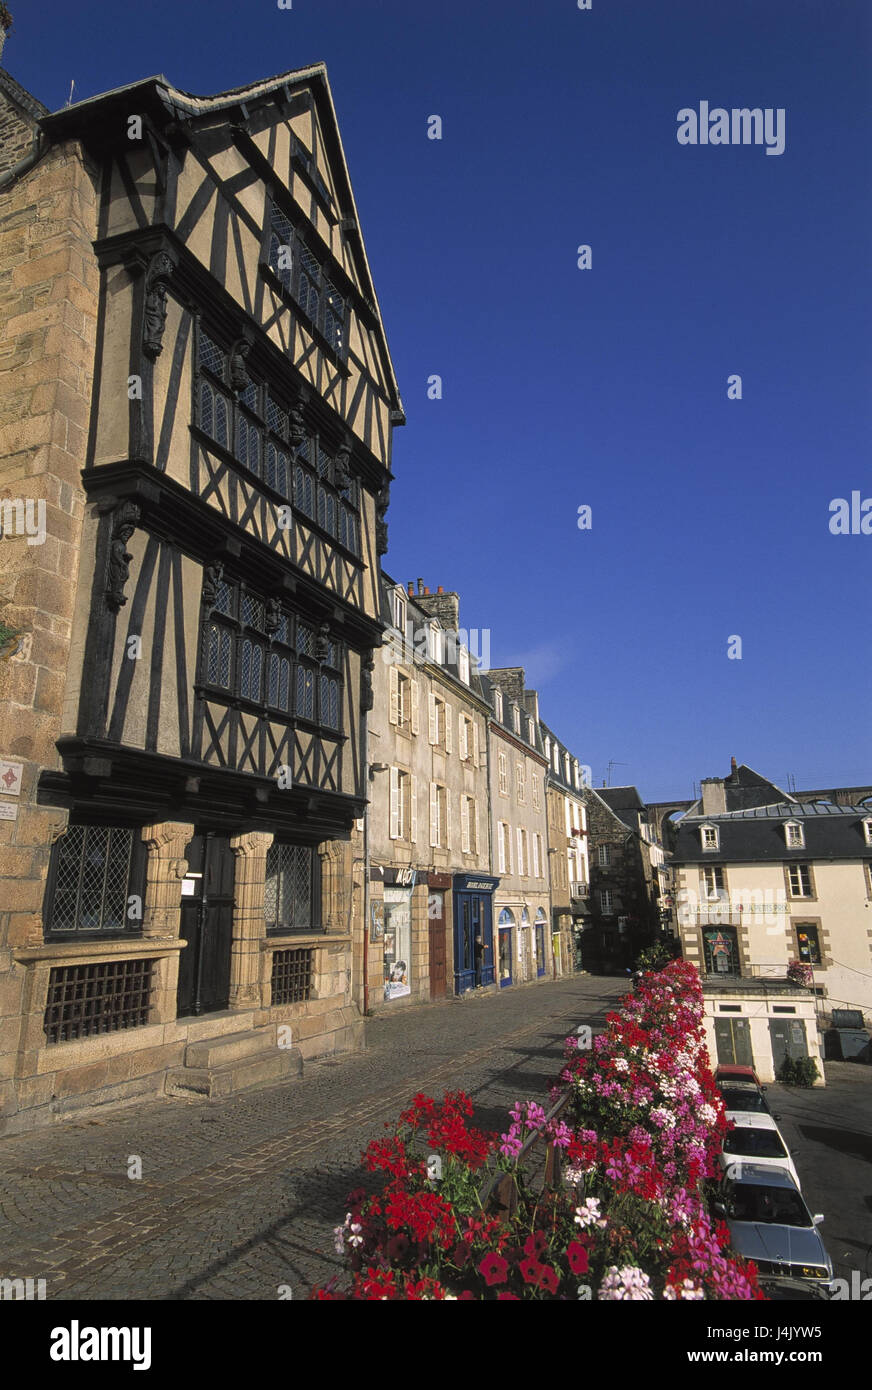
673, 767, 872, 1077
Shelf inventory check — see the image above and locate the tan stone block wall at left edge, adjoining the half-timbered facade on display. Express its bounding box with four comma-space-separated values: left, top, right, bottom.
0, 127, 97, 1115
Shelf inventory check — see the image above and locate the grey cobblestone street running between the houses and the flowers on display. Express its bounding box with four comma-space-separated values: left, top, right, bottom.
0, 976, 626, 1300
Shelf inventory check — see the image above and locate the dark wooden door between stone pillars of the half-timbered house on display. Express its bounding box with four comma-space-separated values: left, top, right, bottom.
177, 831, 234, 1017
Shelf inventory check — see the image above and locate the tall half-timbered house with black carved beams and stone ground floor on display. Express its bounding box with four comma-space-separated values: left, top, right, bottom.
0, 54, 403, 1129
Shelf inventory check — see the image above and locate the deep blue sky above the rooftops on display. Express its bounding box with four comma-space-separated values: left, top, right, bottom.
13, 0, 872, 801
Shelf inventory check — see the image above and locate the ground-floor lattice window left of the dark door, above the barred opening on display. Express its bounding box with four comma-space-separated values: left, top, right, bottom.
45, 824, 142, 935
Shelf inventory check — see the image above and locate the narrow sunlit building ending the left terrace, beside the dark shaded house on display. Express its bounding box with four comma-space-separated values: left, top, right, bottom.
541, 724, 590, 974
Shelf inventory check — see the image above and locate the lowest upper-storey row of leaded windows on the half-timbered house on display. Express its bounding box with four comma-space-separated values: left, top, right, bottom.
202, 580, 342, 733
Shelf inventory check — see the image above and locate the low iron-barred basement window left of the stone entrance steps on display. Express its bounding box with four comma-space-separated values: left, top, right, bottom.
45, 960, 154, 1043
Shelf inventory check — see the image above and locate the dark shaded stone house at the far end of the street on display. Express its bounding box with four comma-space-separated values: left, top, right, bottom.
581, 787, 666, 972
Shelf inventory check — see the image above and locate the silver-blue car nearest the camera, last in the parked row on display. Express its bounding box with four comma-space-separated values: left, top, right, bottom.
713, 1162, 833, 1298
